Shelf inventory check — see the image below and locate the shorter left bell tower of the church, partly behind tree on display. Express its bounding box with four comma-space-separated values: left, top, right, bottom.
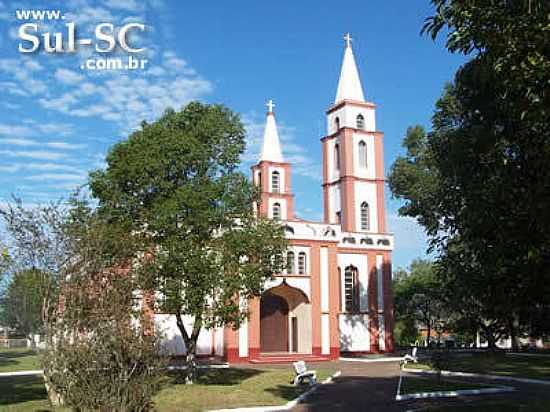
252, 100, 294, 220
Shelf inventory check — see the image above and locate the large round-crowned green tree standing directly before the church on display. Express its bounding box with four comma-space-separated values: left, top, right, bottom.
90, 103, 286, 381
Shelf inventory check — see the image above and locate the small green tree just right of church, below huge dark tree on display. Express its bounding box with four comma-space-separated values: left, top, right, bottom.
393, 259, 447, 345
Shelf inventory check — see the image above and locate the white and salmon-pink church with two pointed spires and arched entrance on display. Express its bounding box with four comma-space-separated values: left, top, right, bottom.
156, 35, 394, 363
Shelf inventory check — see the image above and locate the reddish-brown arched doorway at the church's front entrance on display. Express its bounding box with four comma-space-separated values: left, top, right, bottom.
260, 292, 288, 352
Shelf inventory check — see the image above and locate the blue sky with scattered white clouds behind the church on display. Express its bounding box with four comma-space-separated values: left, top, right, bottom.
0, 0, 470, 267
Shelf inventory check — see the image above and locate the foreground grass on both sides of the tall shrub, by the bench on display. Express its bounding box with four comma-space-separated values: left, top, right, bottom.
0, 368, 334, 412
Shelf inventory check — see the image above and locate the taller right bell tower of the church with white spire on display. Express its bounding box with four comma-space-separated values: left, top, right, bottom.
321, 33, 386, 233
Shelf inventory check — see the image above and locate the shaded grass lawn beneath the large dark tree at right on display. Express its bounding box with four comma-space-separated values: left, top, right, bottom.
410, 353, 550, 380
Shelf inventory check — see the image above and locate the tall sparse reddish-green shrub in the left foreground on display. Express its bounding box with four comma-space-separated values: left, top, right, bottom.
43, 202, 165, 411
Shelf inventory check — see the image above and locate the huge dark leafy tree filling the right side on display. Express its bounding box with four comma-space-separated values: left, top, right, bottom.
390, 0, 550, 346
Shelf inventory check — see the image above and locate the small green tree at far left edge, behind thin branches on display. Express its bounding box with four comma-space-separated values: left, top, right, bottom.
3, 269, 47, 346
